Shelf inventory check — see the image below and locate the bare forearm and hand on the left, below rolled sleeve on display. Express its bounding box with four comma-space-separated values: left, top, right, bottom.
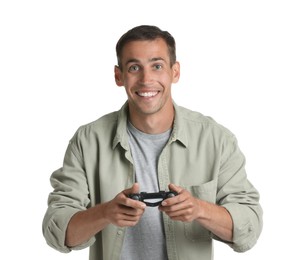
65, 183, 146, 247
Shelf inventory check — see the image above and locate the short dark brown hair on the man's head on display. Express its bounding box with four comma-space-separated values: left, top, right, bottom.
116, 25, 176, 69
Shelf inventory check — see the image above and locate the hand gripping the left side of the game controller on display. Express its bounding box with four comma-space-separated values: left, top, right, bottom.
105, 183, 146, 227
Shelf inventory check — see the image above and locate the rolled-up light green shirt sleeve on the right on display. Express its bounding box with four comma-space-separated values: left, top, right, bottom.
217, 136, 263, 252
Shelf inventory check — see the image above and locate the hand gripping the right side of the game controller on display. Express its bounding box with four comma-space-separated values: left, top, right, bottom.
159, 184, 201, 222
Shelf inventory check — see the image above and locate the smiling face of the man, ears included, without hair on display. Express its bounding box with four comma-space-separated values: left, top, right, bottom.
115, 39, 180, 118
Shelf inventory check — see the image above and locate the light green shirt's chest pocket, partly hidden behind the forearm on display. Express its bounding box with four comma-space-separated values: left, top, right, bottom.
184, 180, 217, 241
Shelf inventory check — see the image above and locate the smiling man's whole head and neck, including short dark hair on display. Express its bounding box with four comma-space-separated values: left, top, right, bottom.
114, 25, 180, 132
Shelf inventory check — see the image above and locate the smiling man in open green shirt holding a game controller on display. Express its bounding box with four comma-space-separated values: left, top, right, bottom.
43, 26, 262, 260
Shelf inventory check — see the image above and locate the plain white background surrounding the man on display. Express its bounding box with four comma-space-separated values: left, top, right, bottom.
0, 0, 304, 260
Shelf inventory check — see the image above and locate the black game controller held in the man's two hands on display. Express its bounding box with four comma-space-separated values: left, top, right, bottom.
129, 191, 177, 207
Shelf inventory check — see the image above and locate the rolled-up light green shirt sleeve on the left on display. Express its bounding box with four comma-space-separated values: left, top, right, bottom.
42, 132, 95, 253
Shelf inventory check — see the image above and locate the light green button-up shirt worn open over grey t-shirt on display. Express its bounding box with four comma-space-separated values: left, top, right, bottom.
43, 103, 262, 260
